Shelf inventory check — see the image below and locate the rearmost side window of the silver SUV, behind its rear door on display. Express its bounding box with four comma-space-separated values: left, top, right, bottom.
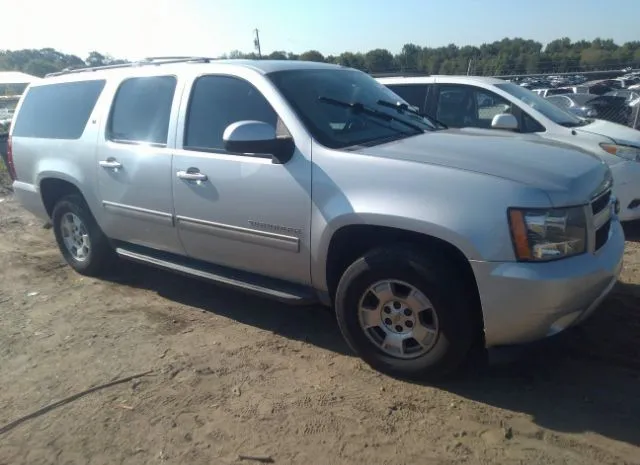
13, 80, 105, 139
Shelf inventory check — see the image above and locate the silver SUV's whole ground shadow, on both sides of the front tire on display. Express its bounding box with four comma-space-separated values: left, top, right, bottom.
102, 263, 640, 446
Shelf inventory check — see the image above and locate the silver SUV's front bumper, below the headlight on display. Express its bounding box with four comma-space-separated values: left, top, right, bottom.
471, 221, 624, 347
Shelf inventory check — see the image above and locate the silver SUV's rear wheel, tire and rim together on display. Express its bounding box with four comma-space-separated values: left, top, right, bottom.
51, 194, 115, 276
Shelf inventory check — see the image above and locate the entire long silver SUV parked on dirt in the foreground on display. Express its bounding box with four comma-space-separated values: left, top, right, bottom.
9, 58, 624, 377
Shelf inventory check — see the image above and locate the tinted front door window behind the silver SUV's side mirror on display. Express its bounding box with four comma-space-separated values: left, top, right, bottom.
184, 76, 278, 150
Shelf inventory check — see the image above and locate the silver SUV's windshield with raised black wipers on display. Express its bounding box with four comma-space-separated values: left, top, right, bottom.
268, 69, 436, 148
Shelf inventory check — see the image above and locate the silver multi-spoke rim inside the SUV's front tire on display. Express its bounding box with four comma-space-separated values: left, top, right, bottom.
358, 280, 439, 359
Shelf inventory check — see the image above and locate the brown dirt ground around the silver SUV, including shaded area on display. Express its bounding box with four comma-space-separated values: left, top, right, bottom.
0, 168, 640, 465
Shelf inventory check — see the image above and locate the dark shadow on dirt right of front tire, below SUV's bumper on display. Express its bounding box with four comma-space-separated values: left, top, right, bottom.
439, 283, 640, 446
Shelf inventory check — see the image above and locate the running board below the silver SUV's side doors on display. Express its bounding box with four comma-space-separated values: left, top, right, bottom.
116, 244, 318, 305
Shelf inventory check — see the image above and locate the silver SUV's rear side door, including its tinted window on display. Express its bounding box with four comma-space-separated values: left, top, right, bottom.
97, 76, 183, 253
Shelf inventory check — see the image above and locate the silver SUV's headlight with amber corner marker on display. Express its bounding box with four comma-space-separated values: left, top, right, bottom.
509, 207, 587, 261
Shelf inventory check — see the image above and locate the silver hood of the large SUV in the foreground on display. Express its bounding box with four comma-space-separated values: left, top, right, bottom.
357, 129, 611, 206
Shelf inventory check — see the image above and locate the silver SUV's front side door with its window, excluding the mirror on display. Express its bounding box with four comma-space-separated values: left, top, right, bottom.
172, 75, 311, 284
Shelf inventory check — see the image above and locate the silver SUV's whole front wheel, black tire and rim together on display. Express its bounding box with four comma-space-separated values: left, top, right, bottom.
335, 247, 479, 380
